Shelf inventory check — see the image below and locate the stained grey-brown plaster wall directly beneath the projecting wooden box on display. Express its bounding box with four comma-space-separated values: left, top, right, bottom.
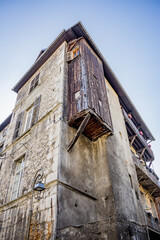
57, 122, 117, 239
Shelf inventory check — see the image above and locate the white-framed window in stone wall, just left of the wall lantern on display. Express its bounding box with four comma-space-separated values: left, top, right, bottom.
11, 156, 24, 200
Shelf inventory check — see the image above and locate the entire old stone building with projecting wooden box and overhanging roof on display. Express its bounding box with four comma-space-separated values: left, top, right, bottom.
0, 23, 160, 240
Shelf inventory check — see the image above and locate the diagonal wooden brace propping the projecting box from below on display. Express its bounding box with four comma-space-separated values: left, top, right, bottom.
67, 113, 91, 152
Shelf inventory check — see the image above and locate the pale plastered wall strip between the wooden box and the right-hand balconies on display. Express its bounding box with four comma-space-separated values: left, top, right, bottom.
106, 81, 146, 239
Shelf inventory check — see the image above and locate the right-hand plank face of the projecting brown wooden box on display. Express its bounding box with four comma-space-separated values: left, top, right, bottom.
81, 39, 112, 127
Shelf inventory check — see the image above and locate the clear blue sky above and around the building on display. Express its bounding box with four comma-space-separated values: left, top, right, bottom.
0, 0, 160, 176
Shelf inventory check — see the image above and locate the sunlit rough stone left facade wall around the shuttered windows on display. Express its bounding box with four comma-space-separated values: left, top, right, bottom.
0, 43, 66, 240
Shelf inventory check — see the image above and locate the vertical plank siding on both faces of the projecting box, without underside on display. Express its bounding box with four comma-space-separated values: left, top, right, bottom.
68, 39, 112, 127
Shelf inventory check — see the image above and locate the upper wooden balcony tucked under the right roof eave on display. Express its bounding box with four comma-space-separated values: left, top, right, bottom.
122, 108, 154, 161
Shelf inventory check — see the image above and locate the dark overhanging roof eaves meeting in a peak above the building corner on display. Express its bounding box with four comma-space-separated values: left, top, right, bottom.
12, 22, 155, 141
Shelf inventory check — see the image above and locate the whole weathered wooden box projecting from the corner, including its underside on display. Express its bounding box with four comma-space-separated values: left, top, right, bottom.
68, 38, 112, 140
